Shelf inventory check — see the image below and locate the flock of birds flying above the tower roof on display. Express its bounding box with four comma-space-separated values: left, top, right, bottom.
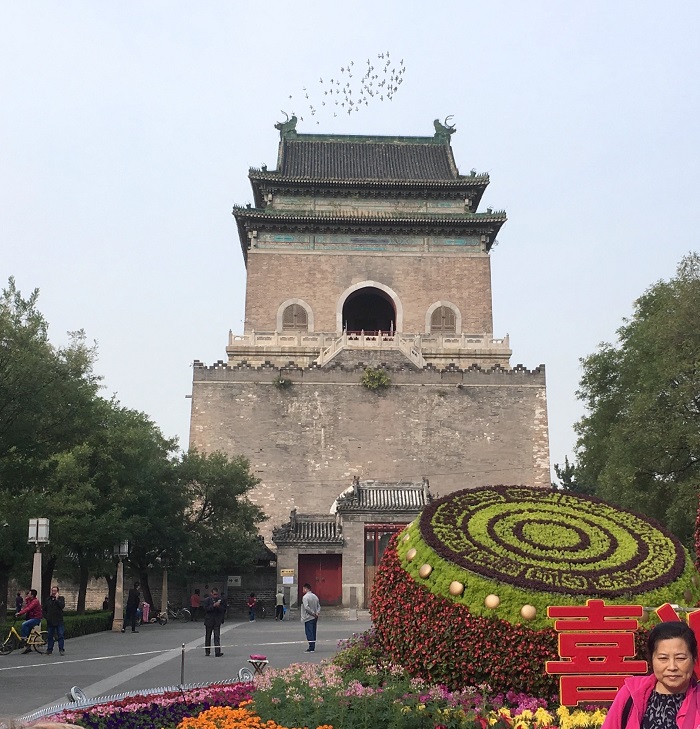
283, 51, 406, 124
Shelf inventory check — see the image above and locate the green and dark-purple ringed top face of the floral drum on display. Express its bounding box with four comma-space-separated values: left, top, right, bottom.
420, 486, 686, 597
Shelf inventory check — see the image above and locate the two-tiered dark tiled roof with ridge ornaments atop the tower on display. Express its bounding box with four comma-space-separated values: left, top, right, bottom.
233, 117, 506, 264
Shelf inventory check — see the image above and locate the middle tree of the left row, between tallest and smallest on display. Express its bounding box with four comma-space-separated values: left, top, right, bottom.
48, 398, 178, 612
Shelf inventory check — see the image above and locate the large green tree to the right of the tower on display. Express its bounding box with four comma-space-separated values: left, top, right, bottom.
574, 254, 700, 545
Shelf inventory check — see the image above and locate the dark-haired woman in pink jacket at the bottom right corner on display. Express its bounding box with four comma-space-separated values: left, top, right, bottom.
603, 622, 700, 729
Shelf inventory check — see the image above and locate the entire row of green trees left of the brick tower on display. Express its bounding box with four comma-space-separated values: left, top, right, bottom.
0, 279, 264, 612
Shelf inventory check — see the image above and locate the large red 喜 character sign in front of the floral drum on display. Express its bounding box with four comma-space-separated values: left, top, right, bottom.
545, 600, 647, 706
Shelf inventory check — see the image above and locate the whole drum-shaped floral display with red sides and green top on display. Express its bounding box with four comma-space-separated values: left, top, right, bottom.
372, 486, 700, 696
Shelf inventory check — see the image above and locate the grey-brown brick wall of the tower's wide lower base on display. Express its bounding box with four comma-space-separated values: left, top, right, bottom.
190, 364, 550, 542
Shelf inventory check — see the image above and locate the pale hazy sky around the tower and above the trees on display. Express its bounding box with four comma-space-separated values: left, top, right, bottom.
0, 0, 700, 475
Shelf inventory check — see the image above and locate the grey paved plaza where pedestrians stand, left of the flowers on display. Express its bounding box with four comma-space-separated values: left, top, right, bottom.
0, 615, 371, 717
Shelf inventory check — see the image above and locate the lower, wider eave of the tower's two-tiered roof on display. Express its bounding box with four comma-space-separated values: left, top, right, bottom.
233, 207, 507, 260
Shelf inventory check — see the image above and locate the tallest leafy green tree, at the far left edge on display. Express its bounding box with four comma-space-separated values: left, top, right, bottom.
0, 278, 99, 598
